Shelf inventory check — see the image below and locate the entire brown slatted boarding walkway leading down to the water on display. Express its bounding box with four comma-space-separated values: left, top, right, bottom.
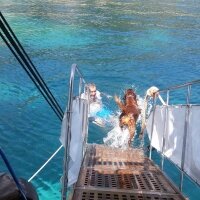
71, 145, 186, 200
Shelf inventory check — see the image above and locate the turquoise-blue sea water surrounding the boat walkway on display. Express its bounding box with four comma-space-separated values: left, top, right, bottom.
0, 0, 200, 200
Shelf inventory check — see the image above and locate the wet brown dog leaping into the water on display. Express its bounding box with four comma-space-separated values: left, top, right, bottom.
115, 89, 140, 146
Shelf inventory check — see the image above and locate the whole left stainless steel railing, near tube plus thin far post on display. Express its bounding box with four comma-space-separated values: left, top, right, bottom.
61, 64, 88, 200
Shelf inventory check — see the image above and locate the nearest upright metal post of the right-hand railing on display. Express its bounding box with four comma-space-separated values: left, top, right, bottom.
179, 85, 191, 191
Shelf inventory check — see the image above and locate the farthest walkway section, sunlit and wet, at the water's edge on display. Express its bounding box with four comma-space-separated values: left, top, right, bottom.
83, 146, 155, 171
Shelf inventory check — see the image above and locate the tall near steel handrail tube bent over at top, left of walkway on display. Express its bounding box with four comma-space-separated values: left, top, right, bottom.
61, 64, 86, 200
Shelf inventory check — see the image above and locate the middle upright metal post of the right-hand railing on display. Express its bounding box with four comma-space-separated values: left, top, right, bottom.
161, 90, 169, 170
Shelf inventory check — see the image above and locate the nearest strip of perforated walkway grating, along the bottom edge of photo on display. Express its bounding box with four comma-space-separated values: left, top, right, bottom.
74, 190, 182, 200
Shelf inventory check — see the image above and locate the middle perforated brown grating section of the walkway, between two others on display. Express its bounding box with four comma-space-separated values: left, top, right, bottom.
77, 169, 175, 193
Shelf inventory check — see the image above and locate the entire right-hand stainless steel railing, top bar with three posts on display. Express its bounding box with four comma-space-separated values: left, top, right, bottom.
149, 80, 200, 191
